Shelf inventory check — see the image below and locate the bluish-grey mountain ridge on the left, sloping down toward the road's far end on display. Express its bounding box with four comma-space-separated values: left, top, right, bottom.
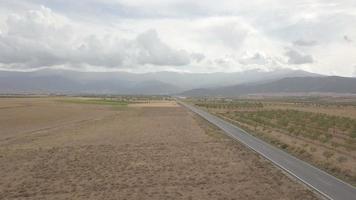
0, 72, 178, 95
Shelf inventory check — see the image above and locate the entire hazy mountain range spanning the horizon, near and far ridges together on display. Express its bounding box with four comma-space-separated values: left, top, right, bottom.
0, 69, 356, 97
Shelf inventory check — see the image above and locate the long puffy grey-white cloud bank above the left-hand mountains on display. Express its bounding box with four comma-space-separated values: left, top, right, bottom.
0, 6, 195, 68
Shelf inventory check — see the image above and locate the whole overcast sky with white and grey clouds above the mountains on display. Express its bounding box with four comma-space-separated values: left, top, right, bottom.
0, 0, 356, 76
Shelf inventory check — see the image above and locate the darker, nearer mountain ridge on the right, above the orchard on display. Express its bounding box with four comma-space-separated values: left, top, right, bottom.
181, 76, 356, 97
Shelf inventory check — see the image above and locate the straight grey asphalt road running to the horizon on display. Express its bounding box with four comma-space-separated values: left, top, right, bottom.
178, 101, 356, 200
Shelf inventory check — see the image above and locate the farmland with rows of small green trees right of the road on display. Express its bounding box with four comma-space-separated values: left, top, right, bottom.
190, 97, 356, 184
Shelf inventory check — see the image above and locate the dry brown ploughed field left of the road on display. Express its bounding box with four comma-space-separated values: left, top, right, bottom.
0, 98, 317, 200
